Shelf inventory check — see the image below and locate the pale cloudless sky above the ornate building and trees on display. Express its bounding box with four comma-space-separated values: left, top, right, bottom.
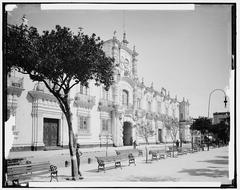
8, 4, 231, 117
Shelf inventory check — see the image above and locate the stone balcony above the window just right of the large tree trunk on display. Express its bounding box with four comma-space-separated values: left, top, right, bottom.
74, 93, 96, 109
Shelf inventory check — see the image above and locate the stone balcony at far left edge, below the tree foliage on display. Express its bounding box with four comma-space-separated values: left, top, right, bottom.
7, 76, 24, 96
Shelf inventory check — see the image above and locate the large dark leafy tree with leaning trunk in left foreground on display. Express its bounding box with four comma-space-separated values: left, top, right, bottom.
6, 24, 114, 180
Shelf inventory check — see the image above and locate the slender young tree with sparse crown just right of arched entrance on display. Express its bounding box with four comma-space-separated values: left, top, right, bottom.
137, 120, 155, 163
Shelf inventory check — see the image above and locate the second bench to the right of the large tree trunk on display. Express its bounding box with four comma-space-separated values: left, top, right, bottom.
116, 149, 143, 165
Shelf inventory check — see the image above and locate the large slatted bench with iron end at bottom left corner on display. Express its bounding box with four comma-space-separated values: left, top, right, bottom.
6, 162, 58, 186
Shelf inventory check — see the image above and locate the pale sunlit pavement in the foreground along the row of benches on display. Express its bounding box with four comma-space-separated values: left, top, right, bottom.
18, 147, 230, 185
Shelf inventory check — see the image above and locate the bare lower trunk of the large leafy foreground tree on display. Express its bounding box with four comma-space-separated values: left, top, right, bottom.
65, 109, 78, 180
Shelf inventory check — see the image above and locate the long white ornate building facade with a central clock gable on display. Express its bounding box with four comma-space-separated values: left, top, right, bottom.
7, 32, 191, 151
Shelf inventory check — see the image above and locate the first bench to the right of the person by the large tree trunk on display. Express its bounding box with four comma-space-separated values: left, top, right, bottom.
96, 156, 122, 172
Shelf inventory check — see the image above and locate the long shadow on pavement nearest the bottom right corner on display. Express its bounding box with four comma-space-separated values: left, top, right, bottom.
179, 169, 228, 178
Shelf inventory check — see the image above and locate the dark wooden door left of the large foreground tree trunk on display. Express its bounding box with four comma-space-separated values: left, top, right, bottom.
43, 118, 59, 146
